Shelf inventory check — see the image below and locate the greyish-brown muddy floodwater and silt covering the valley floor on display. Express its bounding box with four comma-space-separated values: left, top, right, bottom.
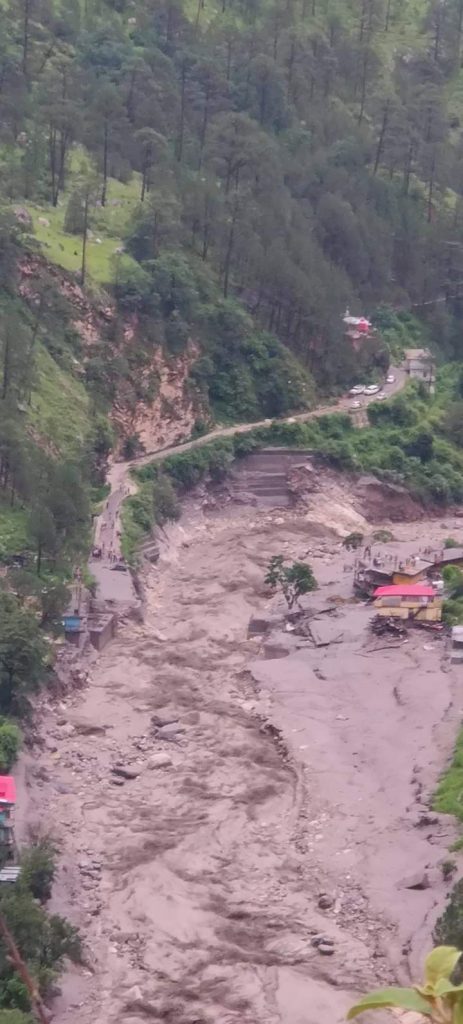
18, 491, 463, 1024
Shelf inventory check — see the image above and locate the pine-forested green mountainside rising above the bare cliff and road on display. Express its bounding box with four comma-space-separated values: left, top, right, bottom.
0, 0, 463, 401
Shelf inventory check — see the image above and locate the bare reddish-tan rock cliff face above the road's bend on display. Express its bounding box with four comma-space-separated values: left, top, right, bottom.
19, 255, 204, 452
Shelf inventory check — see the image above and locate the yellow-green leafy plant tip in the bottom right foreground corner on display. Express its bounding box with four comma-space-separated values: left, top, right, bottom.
347, 946, 463, 1024
